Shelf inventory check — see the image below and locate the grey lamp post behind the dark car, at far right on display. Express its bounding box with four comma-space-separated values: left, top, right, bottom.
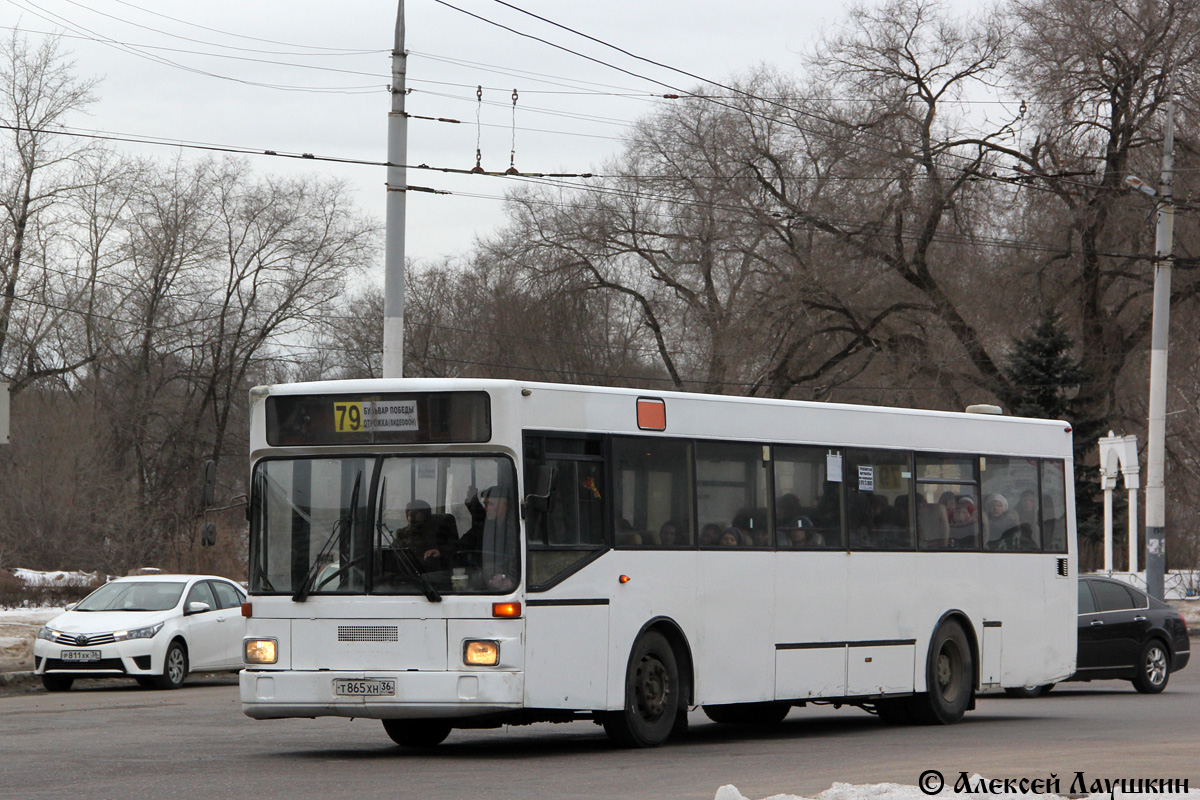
1146, 76, 1175, 600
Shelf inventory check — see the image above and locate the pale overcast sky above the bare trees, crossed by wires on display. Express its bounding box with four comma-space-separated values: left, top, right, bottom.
0, 0, 974, 272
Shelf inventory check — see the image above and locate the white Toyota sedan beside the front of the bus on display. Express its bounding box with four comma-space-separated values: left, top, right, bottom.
34, 575, 246, 692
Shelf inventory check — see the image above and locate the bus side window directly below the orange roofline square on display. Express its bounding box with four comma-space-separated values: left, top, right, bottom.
612, 437, 694, 547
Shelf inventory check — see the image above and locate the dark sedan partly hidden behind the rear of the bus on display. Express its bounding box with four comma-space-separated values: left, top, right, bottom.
1006, 575, 1192, 697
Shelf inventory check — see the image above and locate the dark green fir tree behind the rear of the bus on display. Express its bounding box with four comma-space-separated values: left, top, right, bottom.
1001, 312, 1108, 551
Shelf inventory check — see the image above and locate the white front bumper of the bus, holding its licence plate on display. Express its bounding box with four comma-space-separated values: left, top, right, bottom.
239, 669, 524, 720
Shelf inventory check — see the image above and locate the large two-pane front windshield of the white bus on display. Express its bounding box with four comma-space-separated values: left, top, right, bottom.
250, 455, 521, 601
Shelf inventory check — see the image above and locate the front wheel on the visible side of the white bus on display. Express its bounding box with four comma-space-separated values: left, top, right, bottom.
601, 631, 683, 747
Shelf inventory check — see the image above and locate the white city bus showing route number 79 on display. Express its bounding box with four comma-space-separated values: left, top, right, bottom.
241, 379, 1076, 746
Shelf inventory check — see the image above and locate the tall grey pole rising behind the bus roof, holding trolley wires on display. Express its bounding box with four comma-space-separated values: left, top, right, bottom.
383, 0, 408, 378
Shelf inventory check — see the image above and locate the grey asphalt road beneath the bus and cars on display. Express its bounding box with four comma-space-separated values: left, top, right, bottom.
0, 668, 1200, 800
